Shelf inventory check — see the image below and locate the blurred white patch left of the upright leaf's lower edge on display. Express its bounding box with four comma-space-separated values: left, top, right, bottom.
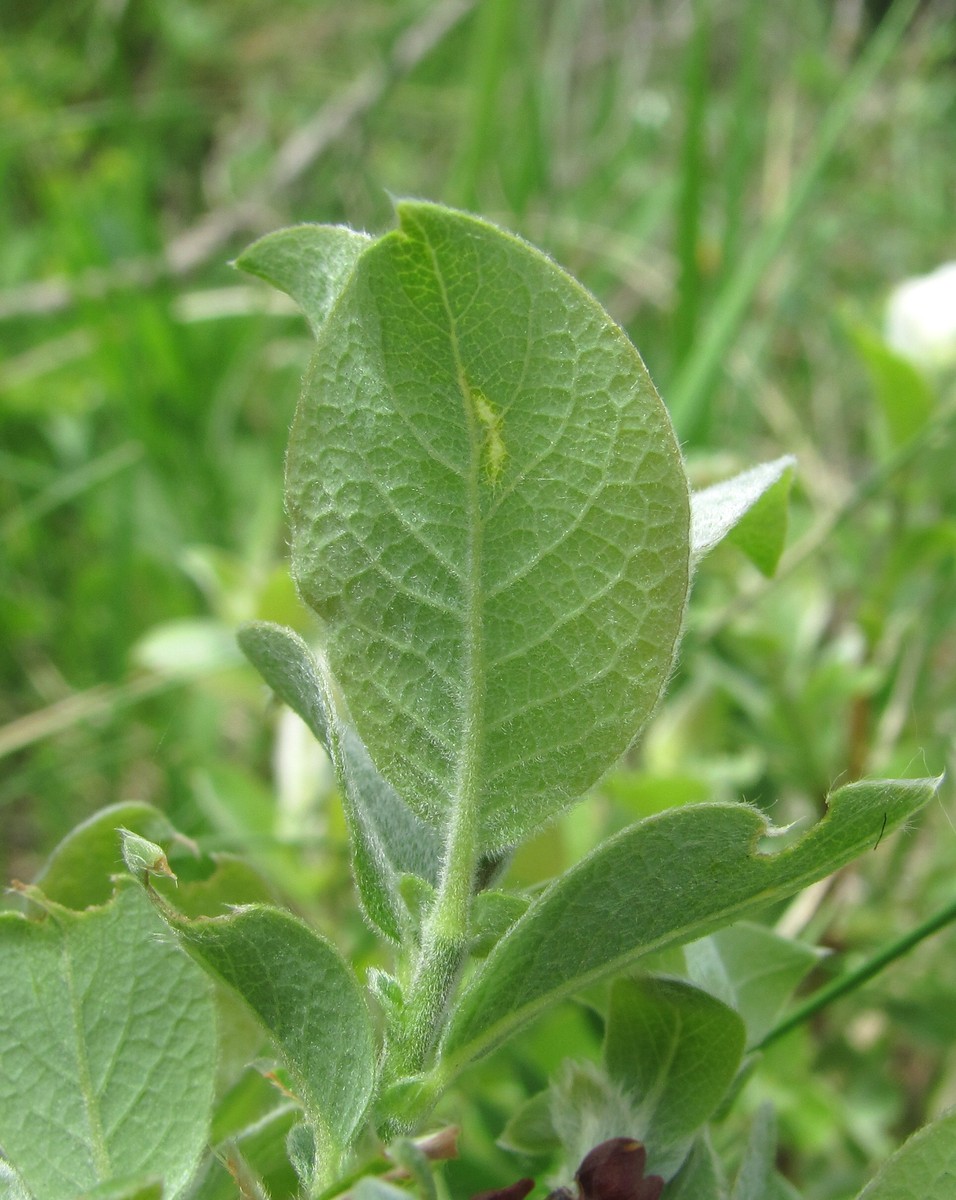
272, 708, 335, 841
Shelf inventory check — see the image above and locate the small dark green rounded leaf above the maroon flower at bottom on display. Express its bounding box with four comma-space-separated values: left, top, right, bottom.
605, 976, 744, 1147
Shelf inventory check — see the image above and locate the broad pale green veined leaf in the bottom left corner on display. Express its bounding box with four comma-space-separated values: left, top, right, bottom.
0, 883, 216, 1200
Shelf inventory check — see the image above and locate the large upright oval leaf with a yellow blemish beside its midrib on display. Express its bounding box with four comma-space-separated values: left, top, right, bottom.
279, 203, 690, 850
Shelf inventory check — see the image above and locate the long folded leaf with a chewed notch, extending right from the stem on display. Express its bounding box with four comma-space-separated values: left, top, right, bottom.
441, 780, 938, 1079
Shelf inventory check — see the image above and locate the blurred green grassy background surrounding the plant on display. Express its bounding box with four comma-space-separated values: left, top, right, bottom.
0, 0, 956, 1200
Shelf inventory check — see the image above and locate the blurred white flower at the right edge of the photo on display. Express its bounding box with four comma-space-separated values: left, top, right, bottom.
885, 263, 956, 370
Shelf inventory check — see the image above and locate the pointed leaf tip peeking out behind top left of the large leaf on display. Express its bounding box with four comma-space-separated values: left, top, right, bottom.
233, 224, 371, 334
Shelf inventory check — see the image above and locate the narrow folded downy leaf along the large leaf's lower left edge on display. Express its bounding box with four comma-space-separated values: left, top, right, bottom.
239, 622, 440, 941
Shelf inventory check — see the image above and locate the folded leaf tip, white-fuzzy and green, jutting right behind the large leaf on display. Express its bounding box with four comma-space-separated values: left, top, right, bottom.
691, 455, 796, 576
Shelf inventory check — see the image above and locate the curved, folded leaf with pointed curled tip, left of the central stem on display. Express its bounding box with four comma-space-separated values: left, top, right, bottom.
162, 905, 375, 1182
